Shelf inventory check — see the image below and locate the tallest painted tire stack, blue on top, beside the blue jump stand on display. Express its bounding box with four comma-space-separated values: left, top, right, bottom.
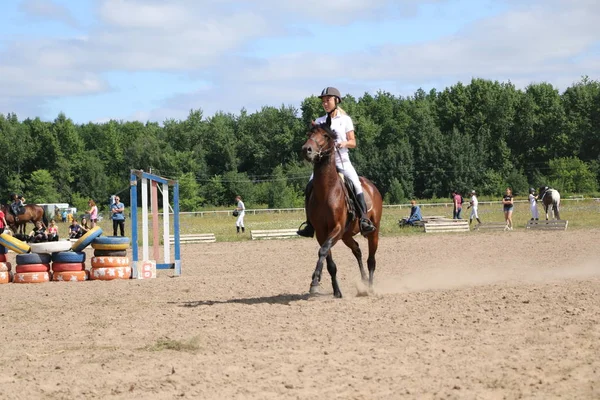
90, 236, 131, 281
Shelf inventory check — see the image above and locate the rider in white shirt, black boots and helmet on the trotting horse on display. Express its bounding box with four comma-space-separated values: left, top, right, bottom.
297, 87, 376, 237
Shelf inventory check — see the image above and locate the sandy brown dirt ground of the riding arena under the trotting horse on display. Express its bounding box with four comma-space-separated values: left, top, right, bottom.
0, 229, 600, 399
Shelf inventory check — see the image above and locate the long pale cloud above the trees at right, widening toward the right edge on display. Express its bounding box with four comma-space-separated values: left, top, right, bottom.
231, 1, 600, 82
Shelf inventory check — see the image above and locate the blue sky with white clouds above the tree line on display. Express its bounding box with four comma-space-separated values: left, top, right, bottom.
0, 0, 600, 123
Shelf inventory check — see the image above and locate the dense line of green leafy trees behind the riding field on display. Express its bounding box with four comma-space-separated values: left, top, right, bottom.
0, 77, 600, 210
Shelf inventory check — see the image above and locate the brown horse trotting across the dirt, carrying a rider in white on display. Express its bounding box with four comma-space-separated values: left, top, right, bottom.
302, 119, 383, 298
